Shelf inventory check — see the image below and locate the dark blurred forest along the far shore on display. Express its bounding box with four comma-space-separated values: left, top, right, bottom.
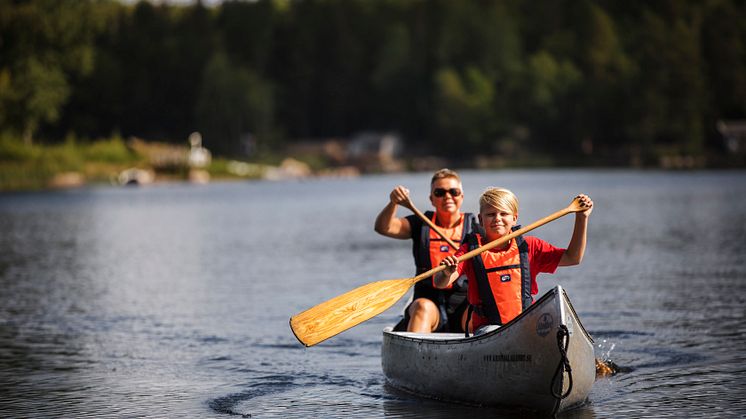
0, 0, 746, 171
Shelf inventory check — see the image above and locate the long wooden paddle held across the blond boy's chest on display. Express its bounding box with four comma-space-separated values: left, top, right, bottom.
290, 199, 587, 346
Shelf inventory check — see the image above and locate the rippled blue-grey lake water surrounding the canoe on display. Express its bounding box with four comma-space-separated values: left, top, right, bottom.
0, 170, 746, 418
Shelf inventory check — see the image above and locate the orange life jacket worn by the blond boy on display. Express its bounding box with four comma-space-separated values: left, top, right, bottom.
467, 231, 533, 325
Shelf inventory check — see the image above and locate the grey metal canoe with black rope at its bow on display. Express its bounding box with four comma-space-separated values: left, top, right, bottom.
381, 286, 596, 414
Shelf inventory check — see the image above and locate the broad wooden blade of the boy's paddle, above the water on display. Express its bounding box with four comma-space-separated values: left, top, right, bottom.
290, 278, 414, 346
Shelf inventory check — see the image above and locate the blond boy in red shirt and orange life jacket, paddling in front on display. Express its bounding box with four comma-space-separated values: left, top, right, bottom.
434, 188, 593, 330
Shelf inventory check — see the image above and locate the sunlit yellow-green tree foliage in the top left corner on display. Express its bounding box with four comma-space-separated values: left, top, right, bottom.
0, 0, 97, 143
